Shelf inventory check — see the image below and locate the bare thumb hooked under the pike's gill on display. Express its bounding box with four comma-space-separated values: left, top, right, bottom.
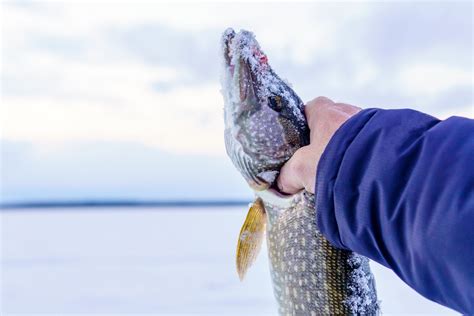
277, 147, 305, 194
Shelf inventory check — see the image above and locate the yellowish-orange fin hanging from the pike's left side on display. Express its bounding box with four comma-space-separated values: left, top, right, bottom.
236, 198, 266, 281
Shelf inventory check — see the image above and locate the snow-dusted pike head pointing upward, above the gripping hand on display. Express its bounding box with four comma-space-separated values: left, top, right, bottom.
221, 29, 309, 191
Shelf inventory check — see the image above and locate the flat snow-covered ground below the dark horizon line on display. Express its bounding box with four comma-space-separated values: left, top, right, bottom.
0, 207, 456, 315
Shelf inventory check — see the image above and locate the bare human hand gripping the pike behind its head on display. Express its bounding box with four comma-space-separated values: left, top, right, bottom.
277, 97, 361, 194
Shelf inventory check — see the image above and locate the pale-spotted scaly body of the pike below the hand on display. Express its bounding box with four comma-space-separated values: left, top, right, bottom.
264, 192, 370, 315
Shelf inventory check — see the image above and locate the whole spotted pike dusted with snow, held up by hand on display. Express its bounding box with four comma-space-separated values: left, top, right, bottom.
221, 28, 380, 316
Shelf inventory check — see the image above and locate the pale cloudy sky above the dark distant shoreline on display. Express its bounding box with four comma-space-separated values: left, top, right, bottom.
0, 1, 474, 203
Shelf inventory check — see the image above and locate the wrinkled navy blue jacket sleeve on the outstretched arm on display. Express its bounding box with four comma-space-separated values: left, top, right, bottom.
316, 109, 474, 314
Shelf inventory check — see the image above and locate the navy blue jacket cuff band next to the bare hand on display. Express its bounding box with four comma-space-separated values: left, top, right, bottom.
314, 109, 379, 249
